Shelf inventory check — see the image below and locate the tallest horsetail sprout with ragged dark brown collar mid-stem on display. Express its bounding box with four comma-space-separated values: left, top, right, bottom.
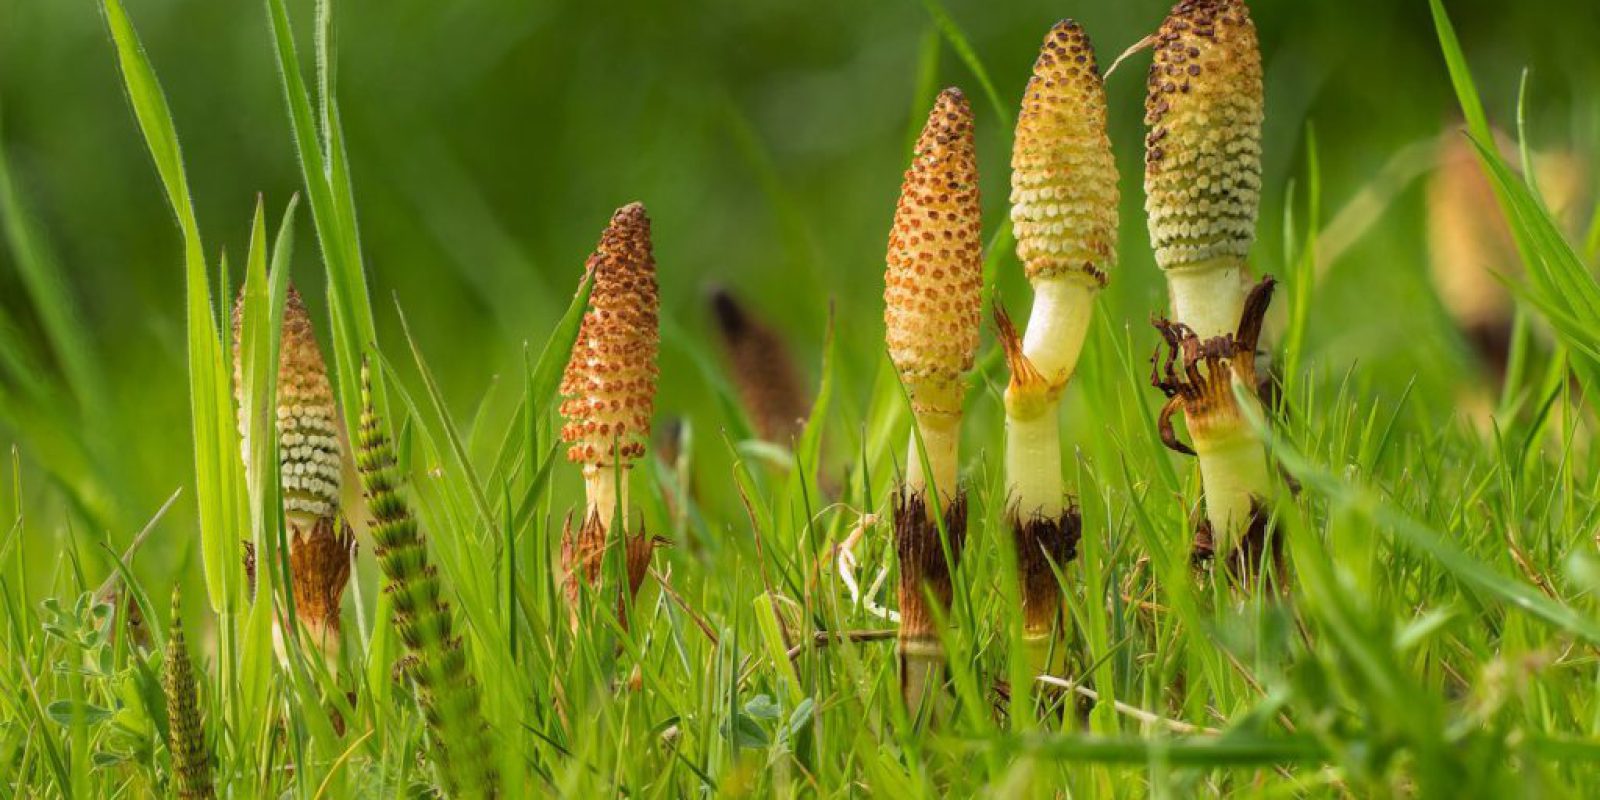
1144, 0, 1272, 576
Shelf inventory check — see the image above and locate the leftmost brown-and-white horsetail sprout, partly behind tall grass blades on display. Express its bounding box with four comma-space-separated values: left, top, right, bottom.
234, 286, 355, 656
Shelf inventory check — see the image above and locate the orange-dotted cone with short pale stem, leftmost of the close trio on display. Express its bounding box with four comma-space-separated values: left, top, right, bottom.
883, 88, 982, 510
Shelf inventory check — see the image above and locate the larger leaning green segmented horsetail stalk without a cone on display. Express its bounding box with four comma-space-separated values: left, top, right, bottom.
355, 365, 496, 797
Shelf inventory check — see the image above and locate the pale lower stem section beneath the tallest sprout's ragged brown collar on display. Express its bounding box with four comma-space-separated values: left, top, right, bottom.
1195, 422, 1272, 557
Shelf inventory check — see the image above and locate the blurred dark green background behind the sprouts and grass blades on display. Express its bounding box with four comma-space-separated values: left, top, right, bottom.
0, 0, 1600, 582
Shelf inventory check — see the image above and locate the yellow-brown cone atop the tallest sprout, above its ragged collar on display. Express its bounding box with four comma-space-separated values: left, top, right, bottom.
1144, 0, 1262, 339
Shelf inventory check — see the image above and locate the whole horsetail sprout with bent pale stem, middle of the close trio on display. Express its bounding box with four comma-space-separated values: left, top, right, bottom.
995, 19, 1118, 672
